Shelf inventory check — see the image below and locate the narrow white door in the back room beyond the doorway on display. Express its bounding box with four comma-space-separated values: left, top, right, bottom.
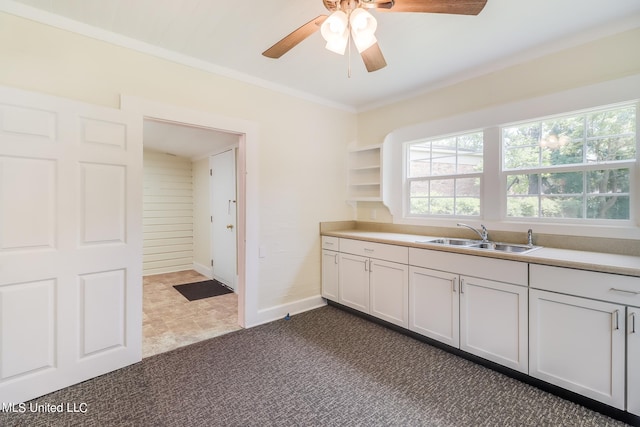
210, 149, 237, 290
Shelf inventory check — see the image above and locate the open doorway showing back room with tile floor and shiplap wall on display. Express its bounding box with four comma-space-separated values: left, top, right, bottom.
142, 118, 242, 357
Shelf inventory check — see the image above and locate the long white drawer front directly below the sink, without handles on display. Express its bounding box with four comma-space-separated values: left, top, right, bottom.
409, 248, 528, 286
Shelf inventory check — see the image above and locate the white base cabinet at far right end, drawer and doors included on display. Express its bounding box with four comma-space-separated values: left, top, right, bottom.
529, 264, 640, 415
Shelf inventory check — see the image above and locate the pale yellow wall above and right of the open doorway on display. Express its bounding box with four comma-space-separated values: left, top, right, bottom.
0, 13, 356, 309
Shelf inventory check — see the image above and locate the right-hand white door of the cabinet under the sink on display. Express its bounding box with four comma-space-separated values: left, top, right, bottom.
460, 276, 528, 373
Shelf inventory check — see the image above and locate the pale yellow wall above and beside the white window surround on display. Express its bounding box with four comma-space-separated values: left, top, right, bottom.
356, 28, 640, 222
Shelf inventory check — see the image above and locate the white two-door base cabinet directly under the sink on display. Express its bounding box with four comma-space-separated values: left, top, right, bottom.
409, 248, 529, 373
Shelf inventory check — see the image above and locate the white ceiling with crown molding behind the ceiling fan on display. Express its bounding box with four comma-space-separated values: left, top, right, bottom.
0, 0, 640, 111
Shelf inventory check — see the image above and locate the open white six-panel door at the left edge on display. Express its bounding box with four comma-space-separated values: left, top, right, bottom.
0, 87, 142, 402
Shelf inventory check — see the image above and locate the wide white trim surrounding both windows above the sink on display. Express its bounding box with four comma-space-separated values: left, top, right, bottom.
382, 74, 640, 239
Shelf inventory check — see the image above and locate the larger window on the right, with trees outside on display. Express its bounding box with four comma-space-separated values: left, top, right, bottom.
502, 105, 636, 220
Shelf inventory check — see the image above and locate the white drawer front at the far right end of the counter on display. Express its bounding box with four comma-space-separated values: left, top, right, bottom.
529, 264, 640, 307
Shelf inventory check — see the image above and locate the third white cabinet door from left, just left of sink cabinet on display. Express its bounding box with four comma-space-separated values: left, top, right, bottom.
369, 259, 409, 328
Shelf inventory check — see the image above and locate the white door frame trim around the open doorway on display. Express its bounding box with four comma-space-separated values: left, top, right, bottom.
120, 95, 261, 328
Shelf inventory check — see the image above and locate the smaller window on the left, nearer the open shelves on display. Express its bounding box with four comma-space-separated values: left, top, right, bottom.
405, 132, 483, 216
